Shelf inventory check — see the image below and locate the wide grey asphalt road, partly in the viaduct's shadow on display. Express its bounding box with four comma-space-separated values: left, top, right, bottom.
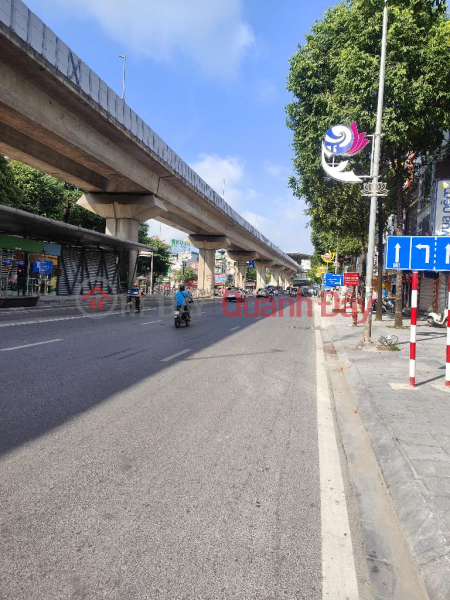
0, 300, 356, 600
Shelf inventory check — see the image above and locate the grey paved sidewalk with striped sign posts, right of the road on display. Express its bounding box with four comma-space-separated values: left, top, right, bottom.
322, 309, 450, 600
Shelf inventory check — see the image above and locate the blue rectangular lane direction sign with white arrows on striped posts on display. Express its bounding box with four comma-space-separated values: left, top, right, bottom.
386, 235, 450, 271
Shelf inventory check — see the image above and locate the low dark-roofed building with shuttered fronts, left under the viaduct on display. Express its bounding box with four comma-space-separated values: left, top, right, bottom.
0, 205, 156, 306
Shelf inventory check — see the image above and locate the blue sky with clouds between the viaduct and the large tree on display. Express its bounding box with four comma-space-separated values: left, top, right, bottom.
26, 0, 330, 252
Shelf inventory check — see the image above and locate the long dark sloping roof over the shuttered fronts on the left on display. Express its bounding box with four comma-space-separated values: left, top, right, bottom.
0, 204, 157, 252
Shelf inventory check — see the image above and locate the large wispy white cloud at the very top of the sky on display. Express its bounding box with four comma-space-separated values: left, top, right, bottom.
47, 0, 255, 79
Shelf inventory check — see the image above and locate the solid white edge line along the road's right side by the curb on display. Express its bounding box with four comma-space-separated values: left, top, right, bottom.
316, 310, 359, 600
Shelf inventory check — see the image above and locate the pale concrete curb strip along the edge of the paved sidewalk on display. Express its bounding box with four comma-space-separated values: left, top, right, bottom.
327, 327, 450, 600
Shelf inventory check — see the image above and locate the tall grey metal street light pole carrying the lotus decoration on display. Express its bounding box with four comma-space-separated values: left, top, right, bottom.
363, 0, 388, 343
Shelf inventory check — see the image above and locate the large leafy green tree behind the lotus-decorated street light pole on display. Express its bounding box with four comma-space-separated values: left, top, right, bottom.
287, 0, 450, 325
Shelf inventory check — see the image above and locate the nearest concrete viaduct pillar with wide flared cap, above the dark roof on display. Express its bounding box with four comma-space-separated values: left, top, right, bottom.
77, 194, 168, 285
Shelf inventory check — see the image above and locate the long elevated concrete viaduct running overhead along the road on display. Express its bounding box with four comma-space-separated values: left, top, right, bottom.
0, 0, 298, 288
